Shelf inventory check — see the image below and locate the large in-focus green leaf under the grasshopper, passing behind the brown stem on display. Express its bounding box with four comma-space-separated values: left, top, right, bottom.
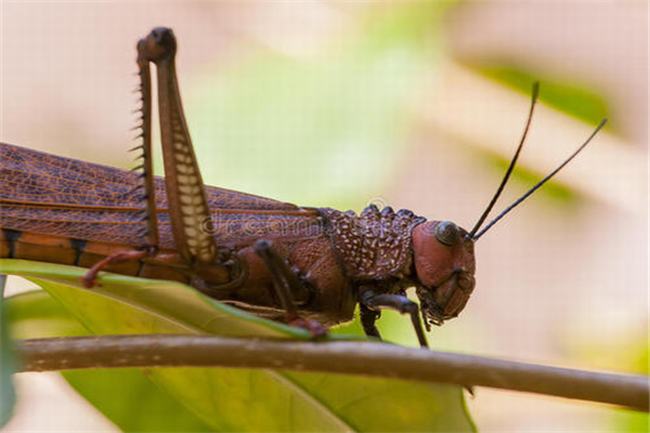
0, 260, 474, 432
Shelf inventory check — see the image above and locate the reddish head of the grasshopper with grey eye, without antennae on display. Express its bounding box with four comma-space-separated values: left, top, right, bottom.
413, 221, 476, 325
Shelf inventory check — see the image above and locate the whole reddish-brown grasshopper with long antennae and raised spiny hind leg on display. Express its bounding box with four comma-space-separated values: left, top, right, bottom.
0, 28, 605, 346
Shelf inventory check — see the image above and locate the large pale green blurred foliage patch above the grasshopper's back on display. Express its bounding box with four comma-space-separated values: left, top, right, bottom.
187, 2, 449, 208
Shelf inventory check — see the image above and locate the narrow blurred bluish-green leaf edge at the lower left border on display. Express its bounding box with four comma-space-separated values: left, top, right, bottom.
0, 274, 16, 427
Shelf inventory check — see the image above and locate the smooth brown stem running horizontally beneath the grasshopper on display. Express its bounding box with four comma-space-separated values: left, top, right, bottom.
18, 335, 650, 411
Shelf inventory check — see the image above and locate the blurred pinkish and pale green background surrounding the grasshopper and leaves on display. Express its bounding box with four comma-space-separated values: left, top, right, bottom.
0, 1, 648, 432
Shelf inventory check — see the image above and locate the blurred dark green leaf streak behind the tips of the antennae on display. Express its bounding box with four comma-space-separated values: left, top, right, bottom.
476, 64, 615, 128
